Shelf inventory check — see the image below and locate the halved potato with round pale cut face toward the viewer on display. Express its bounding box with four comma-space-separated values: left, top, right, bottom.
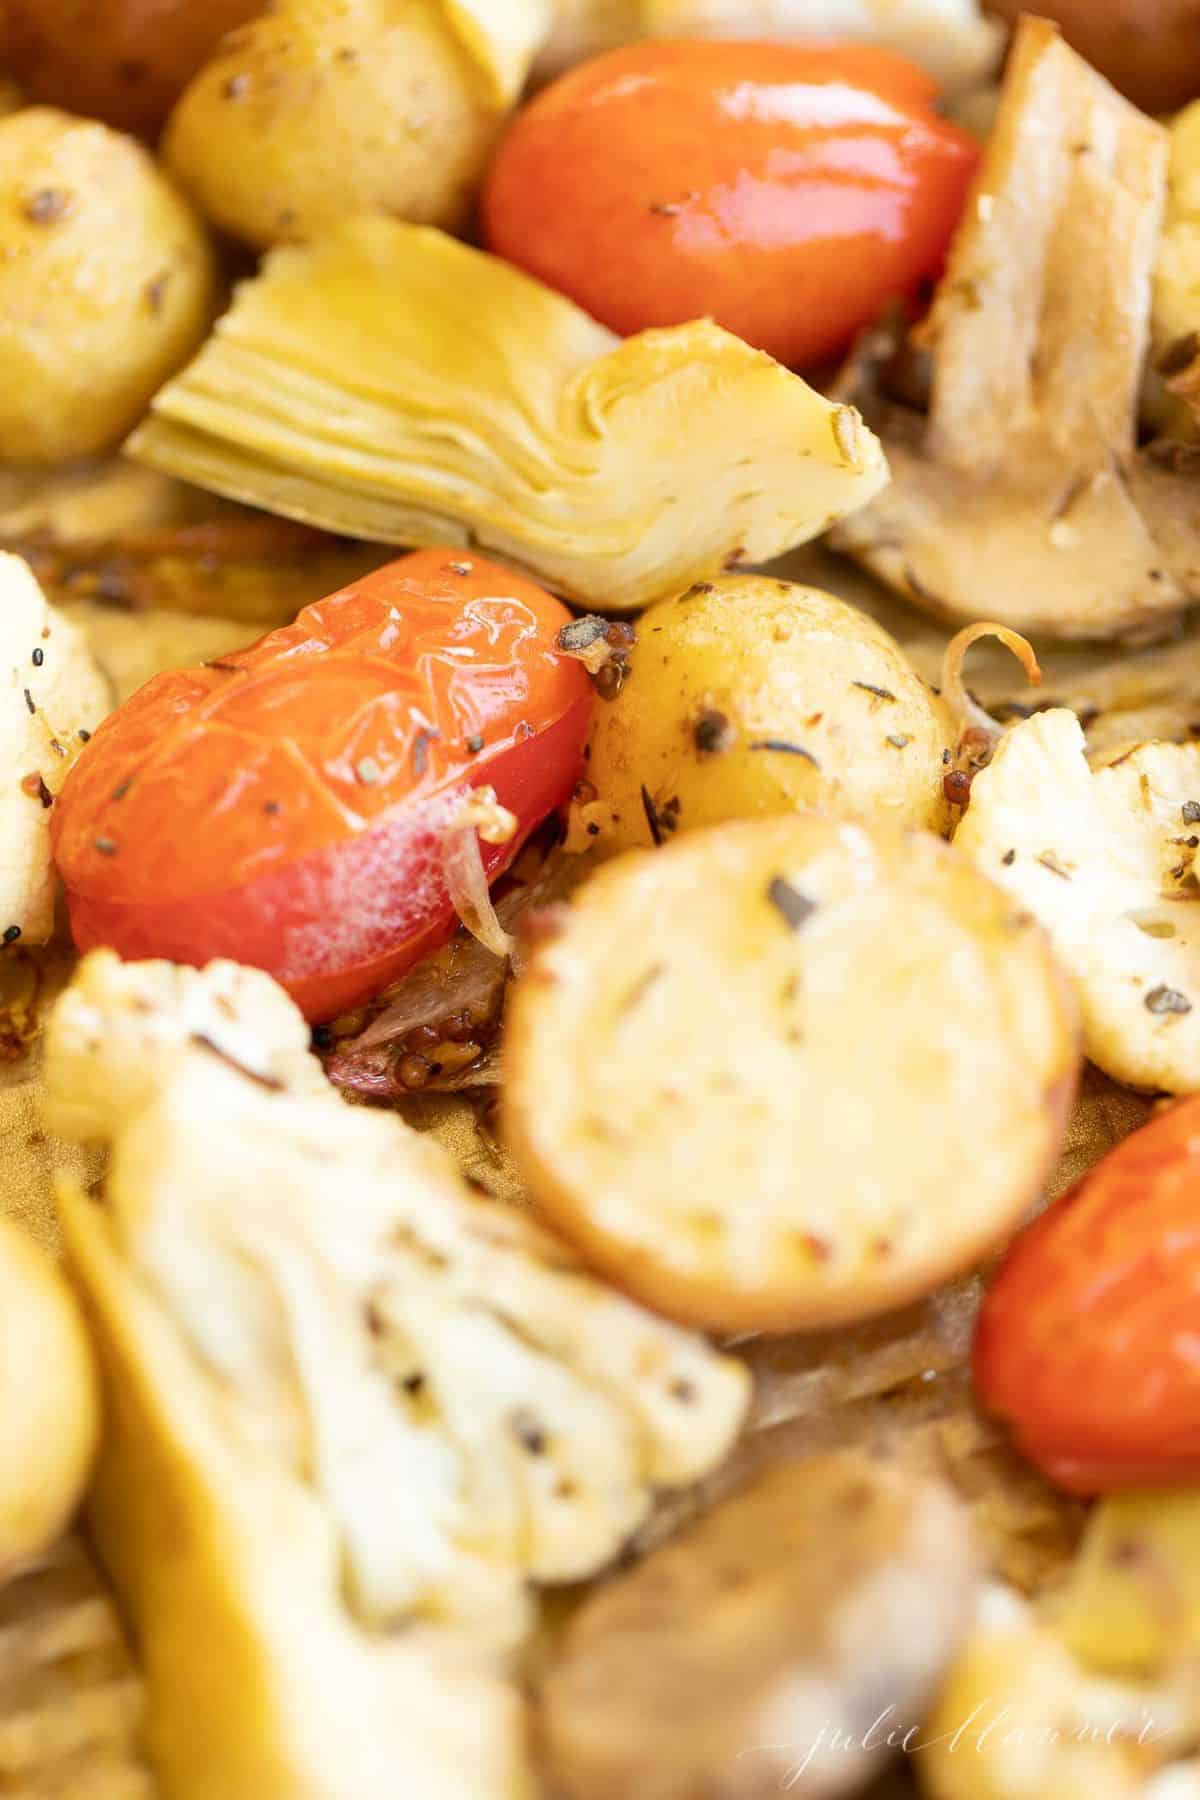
506, 814, 1078, 1330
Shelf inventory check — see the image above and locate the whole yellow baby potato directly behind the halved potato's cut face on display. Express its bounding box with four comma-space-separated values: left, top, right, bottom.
588, 576, 954, 851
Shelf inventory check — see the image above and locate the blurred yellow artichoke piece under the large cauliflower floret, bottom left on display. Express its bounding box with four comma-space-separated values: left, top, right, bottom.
59, 1188, 534, 1800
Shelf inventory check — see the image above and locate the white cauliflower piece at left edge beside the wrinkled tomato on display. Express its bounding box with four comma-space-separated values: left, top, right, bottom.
0, 553, 110, 943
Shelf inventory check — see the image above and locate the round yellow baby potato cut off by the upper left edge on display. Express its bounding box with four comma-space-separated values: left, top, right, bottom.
0, 106, 216, 463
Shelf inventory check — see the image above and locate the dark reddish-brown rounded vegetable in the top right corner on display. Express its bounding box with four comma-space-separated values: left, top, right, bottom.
986, 0, 1200, 113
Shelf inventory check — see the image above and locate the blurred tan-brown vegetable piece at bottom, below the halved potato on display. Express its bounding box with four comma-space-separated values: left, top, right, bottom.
542, 1453, 975, 1800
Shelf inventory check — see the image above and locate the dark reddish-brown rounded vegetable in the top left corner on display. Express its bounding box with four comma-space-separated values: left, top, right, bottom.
0, 0, 264, 137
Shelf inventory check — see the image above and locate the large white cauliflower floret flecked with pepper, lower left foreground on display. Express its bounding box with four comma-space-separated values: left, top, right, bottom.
47, 958, 748, 1645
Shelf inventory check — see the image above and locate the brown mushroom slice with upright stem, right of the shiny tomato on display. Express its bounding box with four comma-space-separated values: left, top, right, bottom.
837, 20, 1200, 639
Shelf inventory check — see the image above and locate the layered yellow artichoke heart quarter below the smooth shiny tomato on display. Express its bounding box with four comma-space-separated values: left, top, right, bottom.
128, 216, 887, 608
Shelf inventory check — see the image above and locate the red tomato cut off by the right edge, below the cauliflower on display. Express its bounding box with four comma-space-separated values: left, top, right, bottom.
973, 1096, 1200, 1494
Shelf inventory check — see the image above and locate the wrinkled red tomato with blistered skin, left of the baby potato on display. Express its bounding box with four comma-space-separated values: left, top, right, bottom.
52, 549, 592, 1019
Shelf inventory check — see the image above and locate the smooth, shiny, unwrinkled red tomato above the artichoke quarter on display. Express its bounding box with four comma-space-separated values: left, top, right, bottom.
482, 41, 981, 367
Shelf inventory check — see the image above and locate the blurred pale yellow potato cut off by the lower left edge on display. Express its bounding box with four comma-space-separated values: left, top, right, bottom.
0, 1215, 99, 1580
